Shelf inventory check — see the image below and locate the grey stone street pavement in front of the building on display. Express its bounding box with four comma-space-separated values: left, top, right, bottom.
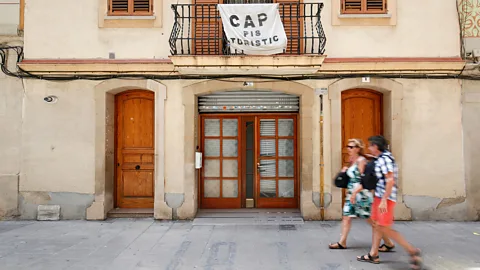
0, 219, 480, 270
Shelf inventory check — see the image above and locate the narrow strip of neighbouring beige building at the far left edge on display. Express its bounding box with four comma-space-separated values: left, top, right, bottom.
0, 0, 24, 219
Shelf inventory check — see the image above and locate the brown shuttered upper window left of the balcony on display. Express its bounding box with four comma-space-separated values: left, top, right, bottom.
108, 0, 153, 16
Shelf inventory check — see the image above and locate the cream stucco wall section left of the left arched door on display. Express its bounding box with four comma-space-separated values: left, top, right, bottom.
20, 80, 95, 194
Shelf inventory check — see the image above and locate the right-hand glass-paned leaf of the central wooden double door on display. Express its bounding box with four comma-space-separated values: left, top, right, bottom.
256, 115, 298, 208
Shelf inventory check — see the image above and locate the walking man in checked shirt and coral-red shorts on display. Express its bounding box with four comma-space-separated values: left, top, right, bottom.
357, 136, 422, 269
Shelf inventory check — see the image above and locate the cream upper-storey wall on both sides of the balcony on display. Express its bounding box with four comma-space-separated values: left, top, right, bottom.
25, 0, 460, 59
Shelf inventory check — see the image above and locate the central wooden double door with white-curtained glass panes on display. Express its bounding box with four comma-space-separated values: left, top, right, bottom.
199, 114, 299, 209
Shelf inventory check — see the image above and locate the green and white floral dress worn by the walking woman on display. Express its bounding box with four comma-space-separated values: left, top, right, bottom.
343, 157, 373, 218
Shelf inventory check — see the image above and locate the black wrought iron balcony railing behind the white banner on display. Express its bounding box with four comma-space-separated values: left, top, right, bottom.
169, 3, 326, 55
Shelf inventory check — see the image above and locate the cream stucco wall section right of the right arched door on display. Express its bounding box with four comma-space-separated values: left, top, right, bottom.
401, 80, 465, 198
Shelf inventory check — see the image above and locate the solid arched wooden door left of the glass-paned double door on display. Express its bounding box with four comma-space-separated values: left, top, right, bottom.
115, 90, 155, 208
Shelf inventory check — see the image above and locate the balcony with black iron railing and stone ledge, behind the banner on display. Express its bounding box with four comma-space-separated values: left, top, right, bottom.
169, 2, 326, 74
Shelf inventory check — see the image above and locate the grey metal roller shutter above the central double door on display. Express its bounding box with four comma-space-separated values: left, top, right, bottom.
198, 91, 300, 113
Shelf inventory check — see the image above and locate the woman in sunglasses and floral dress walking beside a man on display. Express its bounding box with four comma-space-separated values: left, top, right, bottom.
329, 139, 373, 249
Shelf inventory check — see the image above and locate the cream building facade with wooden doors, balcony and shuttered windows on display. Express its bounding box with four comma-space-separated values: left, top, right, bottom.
0, 0, 480, 220
